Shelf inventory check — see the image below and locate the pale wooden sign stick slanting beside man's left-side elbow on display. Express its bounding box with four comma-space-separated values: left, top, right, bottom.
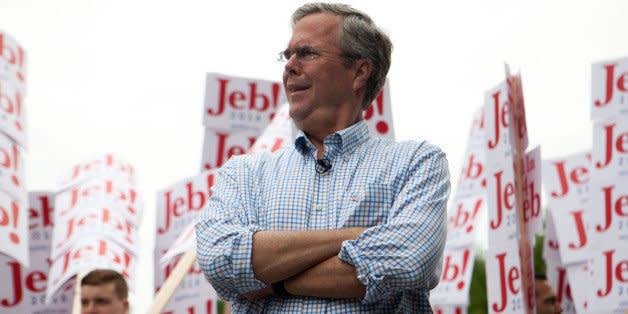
146, 250, 196, 314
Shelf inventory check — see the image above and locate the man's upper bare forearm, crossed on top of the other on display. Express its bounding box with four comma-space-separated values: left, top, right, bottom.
251, 228, 366, 283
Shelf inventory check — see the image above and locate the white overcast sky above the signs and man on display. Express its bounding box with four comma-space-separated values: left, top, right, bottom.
0, 0, 628, 313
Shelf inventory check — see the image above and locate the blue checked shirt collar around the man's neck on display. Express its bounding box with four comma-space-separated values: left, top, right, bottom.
294, 119, 370, 155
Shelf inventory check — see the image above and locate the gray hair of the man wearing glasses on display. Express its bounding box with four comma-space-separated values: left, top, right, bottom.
292, 3, 392, 110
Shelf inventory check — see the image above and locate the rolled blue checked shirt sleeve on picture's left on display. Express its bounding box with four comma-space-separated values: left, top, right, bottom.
196, 158, 267, 301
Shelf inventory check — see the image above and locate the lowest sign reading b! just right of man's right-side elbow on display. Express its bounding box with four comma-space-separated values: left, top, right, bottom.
430, 247, 474, 305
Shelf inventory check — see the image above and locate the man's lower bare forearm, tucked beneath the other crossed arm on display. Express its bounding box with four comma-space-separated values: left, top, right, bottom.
284, 256, 366, 298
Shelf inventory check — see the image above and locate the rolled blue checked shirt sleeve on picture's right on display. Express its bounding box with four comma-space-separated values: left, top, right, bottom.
338, 145, 450, 303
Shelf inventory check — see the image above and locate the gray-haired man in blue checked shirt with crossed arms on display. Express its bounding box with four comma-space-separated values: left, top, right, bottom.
196, 4, 450, 313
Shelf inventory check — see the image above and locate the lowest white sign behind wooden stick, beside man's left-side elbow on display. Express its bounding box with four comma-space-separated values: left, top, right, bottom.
155, 249, 218, 314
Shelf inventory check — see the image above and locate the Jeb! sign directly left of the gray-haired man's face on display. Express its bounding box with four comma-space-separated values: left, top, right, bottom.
203, 73, 286, 134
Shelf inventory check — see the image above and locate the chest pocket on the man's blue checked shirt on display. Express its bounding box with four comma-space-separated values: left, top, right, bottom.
338, 184, 394, 228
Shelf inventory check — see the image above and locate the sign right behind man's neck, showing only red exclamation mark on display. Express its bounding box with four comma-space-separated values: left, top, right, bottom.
364, 80, 395, 140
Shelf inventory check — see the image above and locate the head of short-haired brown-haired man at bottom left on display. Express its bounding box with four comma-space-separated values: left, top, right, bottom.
81, 269, 129, 314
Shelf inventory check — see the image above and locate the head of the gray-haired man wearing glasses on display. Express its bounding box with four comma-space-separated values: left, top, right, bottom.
282, 3, 392, 131
